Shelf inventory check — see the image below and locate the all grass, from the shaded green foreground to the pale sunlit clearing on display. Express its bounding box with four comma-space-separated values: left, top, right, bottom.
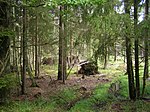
0, 59, 150, 112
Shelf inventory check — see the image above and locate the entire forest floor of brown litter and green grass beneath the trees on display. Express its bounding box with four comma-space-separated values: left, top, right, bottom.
0, 62, 150, 112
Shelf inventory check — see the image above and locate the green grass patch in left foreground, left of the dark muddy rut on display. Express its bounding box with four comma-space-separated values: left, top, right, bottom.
0, 89, 76, 112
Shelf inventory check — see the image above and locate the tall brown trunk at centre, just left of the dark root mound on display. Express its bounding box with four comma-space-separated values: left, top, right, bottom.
58, 6, 67, 83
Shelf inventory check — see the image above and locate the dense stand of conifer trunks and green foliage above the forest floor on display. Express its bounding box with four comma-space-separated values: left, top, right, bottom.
0, 0, 150, 111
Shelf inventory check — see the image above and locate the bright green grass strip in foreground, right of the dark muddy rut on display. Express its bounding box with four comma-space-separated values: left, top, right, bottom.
70, 84, 110, 112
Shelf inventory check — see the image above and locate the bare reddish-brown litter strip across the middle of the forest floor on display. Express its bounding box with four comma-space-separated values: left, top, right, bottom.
13, 74, 112, 101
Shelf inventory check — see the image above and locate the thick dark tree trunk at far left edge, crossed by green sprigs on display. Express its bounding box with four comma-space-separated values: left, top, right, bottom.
0, 1, 10, 76
